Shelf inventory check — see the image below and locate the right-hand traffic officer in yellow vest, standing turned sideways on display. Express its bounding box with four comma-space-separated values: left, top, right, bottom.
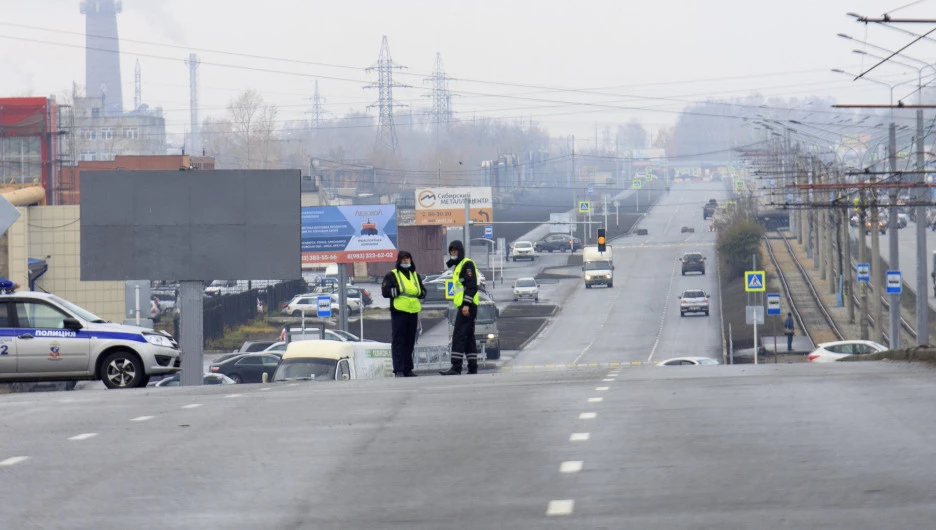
439, 241, 480, 375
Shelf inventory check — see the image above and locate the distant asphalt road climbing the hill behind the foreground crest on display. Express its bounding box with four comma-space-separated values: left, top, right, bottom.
514, 179, 724, 365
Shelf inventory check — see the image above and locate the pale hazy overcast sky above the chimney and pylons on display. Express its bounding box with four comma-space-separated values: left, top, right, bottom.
0, 0, 936, 141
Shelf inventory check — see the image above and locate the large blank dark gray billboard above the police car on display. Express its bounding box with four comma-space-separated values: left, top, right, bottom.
81, 170, 301, 281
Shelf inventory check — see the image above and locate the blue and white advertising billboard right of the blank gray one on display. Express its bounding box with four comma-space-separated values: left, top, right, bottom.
301, 204, 397, 263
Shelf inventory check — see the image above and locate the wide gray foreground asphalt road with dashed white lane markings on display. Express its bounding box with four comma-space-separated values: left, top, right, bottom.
0, 363, 936, 529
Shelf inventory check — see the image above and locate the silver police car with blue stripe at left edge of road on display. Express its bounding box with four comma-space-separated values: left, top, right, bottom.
0, 281, 181, 388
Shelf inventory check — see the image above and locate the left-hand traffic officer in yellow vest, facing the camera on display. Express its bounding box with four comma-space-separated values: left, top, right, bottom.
380, 250, 426, 377
